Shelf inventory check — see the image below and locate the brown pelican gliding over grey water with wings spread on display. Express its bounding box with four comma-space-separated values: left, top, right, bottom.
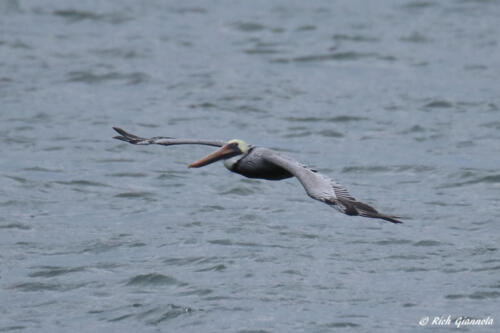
113, 127, 402, 223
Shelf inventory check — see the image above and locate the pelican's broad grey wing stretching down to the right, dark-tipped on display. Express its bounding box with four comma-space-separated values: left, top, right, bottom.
261, 149, 402, 223
